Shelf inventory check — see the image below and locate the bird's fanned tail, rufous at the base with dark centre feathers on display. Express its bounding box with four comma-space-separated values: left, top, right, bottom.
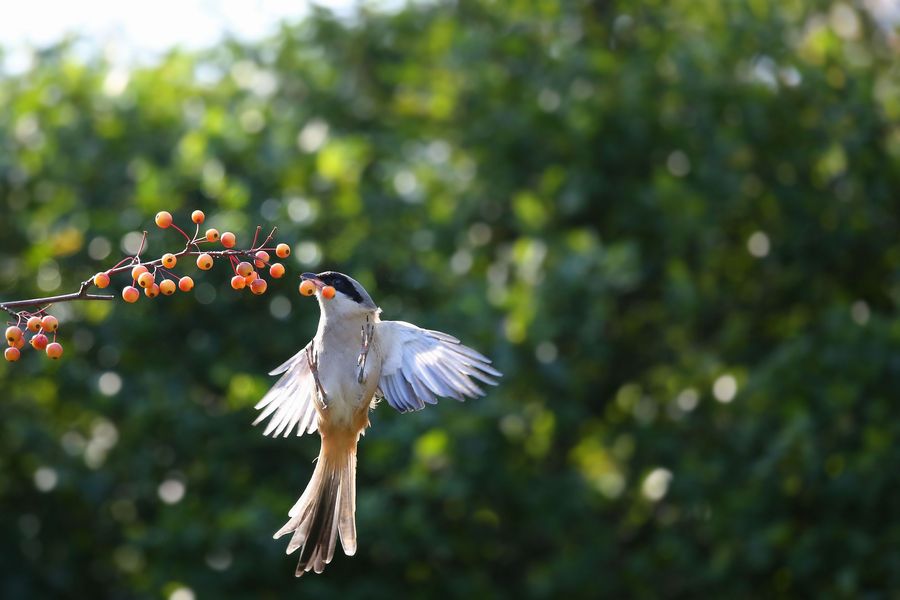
275, 432, 359, 577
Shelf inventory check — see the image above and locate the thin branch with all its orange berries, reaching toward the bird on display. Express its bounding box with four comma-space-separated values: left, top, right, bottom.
0, 210, 291, 362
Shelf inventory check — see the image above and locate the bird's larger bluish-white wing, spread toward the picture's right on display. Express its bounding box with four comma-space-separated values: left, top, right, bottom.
375, 321, 502, 412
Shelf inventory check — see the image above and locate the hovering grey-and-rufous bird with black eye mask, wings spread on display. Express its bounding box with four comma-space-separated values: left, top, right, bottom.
253, 271, 502, 577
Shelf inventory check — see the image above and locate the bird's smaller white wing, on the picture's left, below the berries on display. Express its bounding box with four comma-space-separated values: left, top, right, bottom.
253, 342, 318, 437
